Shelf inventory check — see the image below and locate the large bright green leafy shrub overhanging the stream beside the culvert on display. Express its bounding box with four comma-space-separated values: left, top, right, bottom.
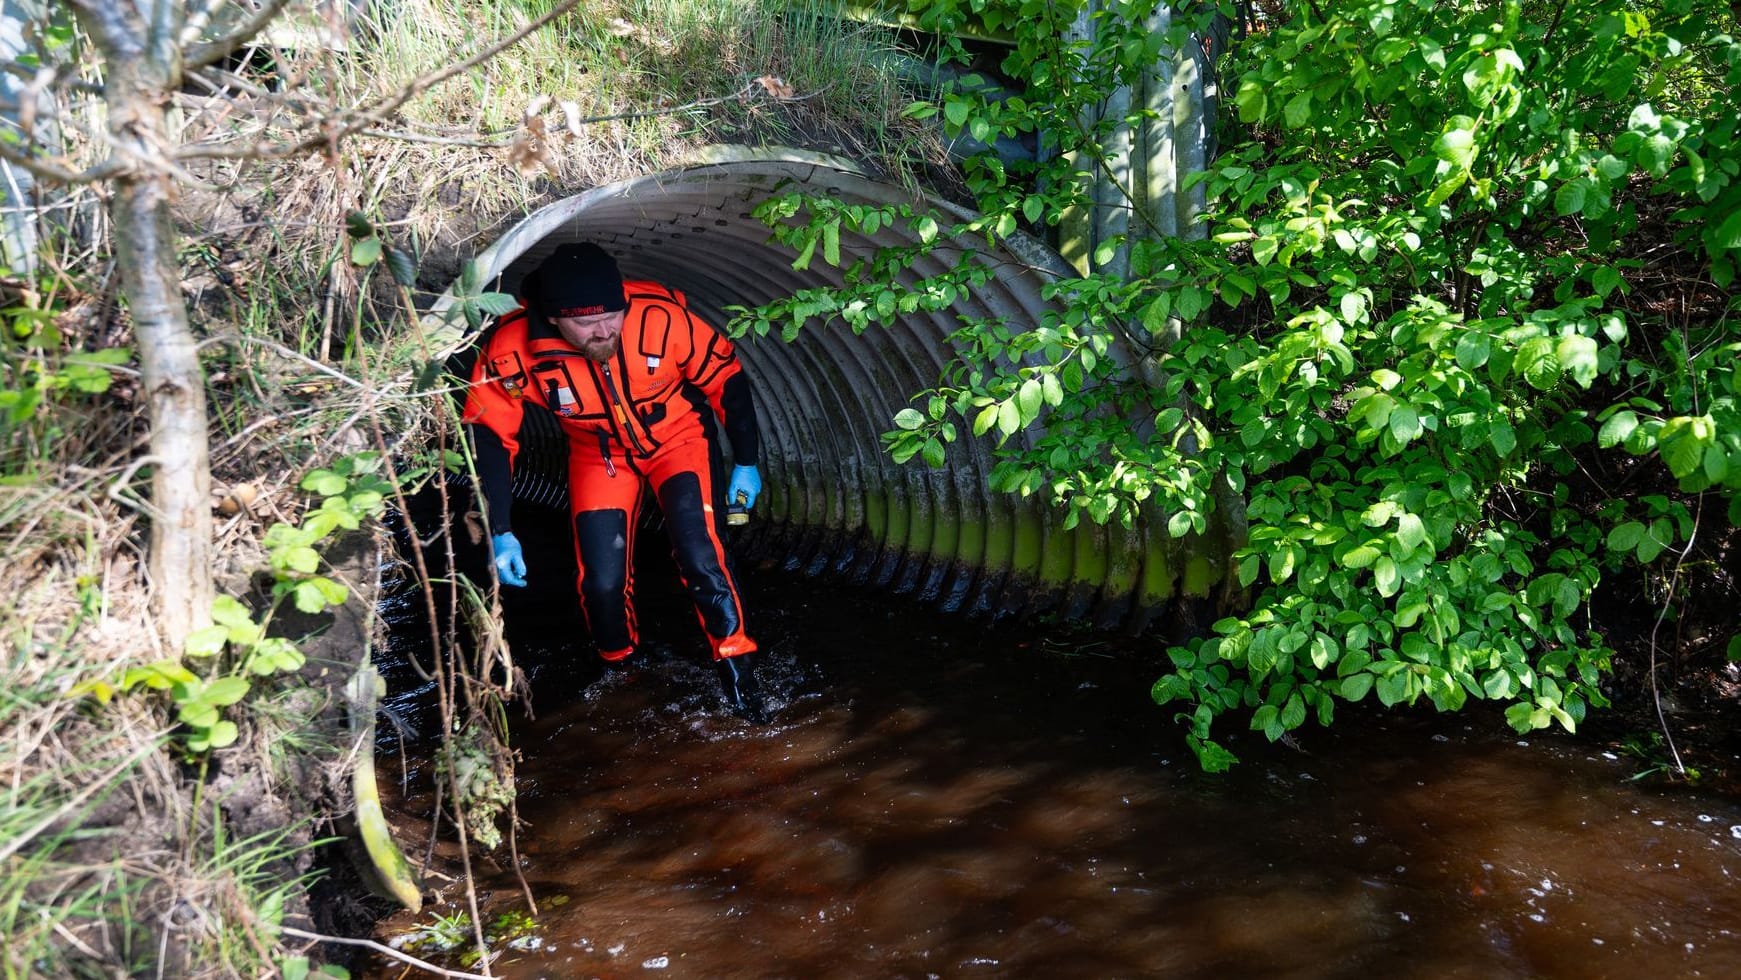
747, 0, 1741, 769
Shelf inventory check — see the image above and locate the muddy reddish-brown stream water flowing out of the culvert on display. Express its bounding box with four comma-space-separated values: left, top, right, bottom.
362, 539, 1741, 978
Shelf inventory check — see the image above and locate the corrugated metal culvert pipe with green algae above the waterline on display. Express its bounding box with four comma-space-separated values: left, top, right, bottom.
430, 148, 1238, 628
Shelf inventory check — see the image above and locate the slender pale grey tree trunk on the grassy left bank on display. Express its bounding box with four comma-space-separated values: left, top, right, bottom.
104, 32, 212, 653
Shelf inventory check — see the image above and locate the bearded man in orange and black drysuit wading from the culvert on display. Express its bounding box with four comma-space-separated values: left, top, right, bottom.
465, 244, 766, 722
